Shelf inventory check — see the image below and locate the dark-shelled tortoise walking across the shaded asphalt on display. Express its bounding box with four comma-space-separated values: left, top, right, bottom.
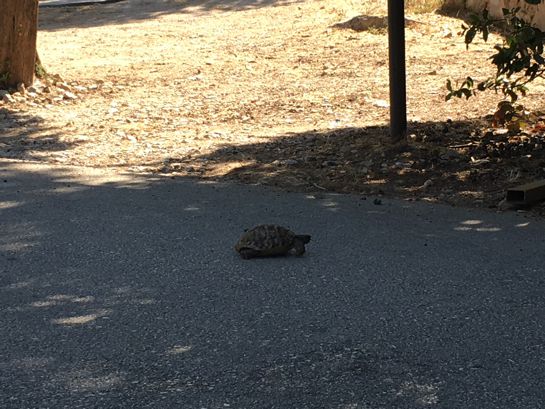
235, 224, 310, 259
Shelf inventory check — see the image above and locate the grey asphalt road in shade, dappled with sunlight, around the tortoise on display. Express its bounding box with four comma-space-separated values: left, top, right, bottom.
0, 161, 545, 409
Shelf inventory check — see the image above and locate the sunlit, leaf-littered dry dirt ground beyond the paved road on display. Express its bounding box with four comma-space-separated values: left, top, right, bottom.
0, 0, 545, 213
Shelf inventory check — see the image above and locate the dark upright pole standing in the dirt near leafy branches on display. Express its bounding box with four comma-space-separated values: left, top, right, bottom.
388, 0, 407, 141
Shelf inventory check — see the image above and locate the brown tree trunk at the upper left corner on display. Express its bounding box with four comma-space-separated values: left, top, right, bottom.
0, 0, 38, 87
